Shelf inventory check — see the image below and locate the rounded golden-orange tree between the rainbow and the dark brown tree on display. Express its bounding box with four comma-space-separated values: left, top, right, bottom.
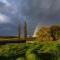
36, 27, 52, 41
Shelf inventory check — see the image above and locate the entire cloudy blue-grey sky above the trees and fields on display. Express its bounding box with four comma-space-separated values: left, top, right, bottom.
0, 0, 60, 35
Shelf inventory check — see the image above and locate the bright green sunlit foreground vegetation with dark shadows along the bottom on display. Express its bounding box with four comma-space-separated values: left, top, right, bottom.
0, 41, 60, 60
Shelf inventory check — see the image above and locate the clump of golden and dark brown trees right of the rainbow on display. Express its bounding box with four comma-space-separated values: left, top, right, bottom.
36, 25, 60, 41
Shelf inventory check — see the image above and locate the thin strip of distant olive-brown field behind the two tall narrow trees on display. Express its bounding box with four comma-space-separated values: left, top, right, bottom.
0, 36, 36, 41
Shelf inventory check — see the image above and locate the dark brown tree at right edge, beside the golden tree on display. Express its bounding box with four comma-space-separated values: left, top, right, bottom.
50, 25, 60, 40
